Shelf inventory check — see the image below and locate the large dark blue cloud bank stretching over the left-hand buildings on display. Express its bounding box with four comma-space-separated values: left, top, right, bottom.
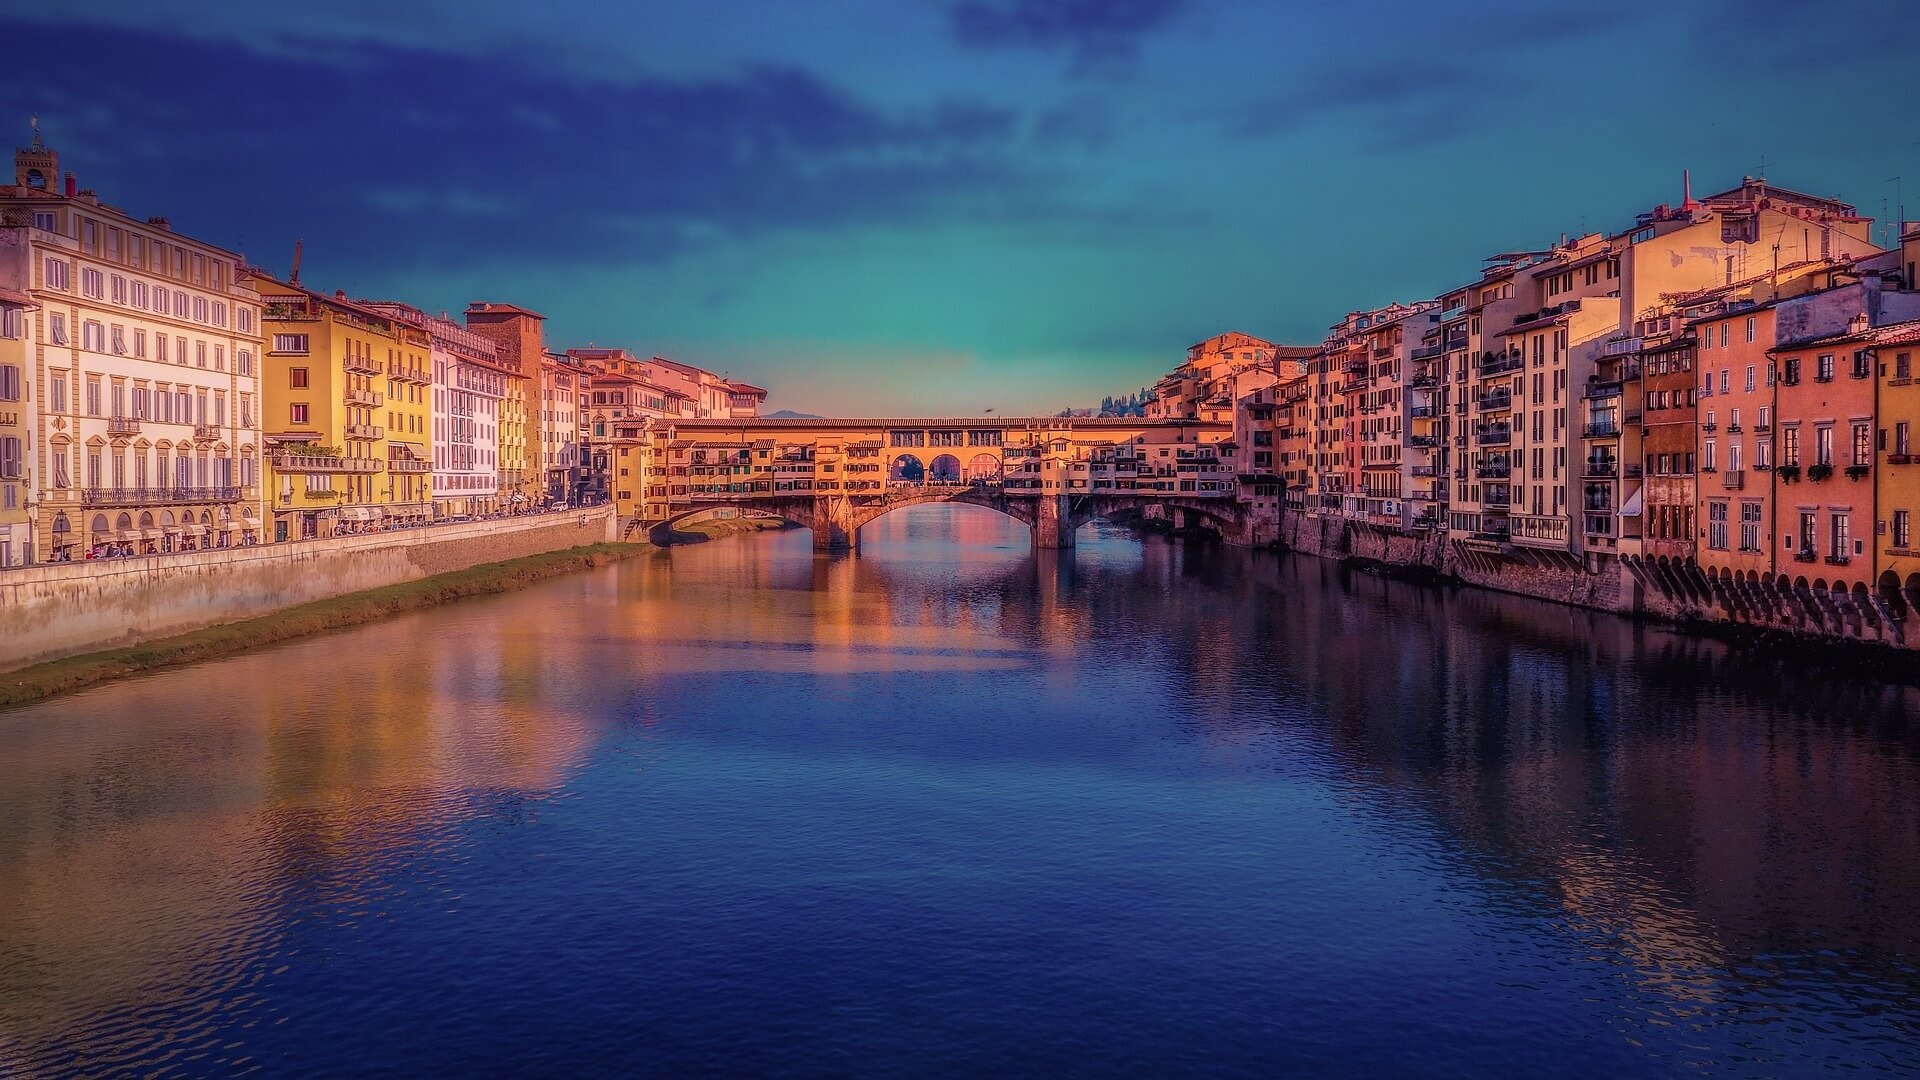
0, 21, 1054, 267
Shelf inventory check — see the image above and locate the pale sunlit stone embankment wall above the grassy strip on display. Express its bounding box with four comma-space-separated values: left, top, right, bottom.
0, 505, 618, 671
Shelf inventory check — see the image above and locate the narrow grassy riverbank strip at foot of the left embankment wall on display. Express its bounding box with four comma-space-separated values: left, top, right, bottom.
0, 544, 651, 707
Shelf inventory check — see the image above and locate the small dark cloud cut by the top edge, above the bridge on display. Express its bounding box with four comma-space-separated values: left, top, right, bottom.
947, 0, 1185, 63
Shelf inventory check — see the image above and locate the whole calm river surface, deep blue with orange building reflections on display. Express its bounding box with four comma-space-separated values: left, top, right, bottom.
0, 507, 1920, 1076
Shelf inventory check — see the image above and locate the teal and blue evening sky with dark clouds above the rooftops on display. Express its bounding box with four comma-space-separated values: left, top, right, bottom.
0, 0, 1920, 415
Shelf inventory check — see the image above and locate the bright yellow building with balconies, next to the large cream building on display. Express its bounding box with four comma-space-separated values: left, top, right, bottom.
253, 273, 432, 540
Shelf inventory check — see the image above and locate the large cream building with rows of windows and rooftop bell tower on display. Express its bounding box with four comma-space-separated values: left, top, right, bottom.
0, 133, 263, 559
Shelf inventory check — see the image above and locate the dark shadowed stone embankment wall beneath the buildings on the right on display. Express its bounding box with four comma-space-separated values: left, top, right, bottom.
1281, 513, 1920, 648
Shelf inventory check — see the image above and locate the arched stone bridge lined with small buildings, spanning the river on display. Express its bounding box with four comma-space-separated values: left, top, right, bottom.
616, 417, 1244, 552
